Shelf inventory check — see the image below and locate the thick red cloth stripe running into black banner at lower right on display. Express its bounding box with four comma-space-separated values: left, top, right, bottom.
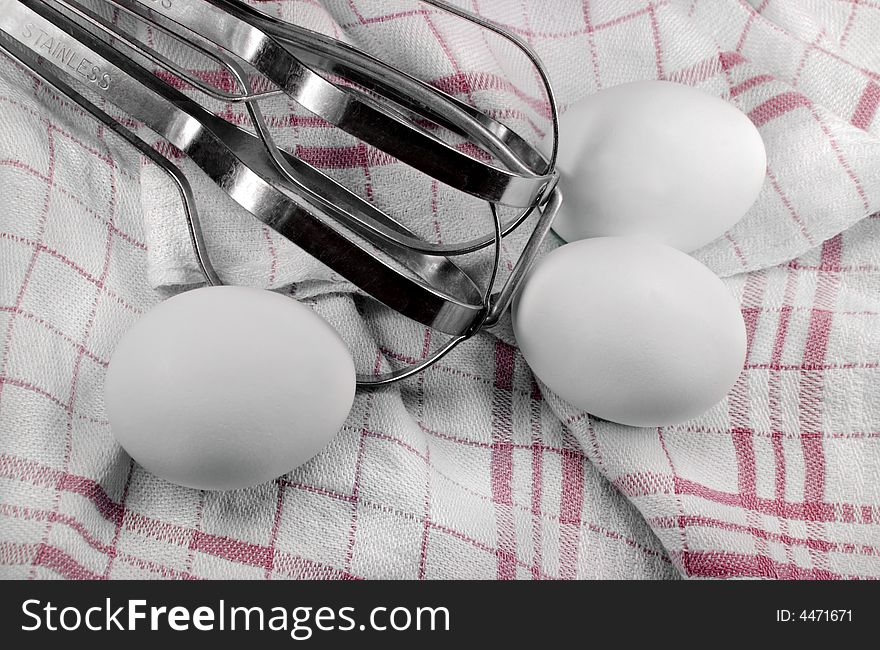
682, 551, 842, 580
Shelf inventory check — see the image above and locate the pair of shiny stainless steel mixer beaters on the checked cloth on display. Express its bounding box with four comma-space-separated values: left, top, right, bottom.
0, 0, 562, 387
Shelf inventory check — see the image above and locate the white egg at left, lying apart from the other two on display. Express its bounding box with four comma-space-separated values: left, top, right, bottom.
104, 287, 355, 490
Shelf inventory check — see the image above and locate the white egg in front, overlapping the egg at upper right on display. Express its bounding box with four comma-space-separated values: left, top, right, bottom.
513, 237, 746, 427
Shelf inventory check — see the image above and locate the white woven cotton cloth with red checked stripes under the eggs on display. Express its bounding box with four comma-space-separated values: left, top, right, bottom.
0, 0, 880, 579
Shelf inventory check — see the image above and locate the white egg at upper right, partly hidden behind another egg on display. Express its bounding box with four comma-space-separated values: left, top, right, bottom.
554, 81, 767, 252
